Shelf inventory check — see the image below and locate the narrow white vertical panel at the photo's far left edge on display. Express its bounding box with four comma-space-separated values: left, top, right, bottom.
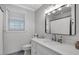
0, 10, 3, 55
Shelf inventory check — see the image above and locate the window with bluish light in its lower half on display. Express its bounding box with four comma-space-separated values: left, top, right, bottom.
8, 12, 25, 31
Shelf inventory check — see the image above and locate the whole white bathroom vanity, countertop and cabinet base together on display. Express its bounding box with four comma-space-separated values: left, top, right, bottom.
31, 38, 79, 55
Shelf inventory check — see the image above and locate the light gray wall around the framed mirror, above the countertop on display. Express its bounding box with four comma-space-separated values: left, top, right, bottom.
35, 5, 79, 45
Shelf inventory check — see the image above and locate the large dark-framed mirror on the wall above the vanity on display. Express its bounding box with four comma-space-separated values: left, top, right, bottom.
45, 4, 76, 35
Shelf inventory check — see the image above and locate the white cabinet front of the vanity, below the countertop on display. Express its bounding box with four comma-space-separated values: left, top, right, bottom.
31, 41, 60, 55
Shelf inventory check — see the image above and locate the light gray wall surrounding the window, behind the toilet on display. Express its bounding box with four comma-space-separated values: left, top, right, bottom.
4, 5, 35, 54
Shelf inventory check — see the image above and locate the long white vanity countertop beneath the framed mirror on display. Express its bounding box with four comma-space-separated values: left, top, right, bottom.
32, 38, 79, 55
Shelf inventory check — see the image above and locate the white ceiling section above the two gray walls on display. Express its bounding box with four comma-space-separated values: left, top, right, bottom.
14, 4, 43, 11
